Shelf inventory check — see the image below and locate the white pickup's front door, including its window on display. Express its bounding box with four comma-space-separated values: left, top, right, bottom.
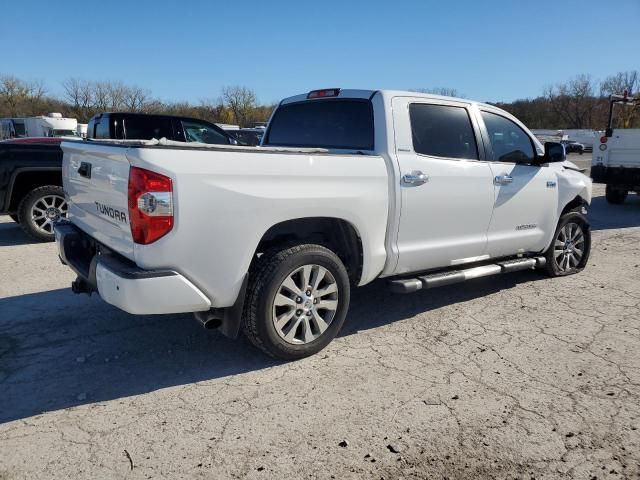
478, 108, 558, 258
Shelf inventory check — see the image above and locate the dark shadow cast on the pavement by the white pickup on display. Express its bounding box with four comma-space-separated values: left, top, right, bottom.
0, 272, 543, 423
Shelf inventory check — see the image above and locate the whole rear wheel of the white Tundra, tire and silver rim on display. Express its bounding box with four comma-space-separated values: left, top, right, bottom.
243, 244, 350, 360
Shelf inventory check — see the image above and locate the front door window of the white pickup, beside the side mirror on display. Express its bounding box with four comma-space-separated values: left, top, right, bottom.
482, 112, 535, 163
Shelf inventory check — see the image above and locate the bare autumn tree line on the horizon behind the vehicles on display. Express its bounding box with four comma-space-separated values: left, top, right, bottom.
0, 70, 640, 130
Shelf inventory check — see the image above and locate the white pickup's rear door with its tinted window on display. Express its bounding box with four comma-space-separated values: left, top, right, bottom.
392, 97, 494, 274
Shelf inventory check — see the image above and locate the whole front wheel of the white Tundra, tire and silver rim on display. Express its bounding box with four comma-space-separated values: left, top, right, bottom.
545, 212, 591, 277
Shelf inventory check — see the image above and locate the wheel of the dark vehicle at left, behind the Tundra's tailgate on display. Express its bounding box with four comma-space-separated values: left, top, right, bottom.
18, 185, 67, 242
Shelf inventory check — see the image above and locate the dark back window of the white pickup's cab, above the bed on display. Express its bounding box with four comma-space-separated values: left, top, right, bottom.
264, 99, 373, 150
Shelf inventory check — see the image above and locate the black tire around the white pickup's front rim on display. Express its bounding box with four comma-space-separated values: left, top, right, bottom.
544, 211, 591, 277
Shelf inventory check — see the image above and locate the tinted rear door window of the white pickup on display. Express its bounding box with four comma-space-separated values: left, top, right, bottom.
409, 103, 478, 160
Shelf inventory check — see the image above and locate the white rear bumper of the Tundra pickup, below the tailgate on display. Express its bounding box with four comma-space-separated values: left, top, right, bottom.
54, 222, 211, 315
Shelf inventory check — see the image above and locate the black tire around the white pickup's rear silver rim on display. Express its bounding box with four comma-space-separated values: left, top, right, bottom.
242, 244, 350, 360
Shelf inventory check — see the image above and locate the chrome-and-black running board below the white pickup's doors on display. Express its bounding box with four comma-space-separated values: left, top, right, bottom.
388, 257, 546, 293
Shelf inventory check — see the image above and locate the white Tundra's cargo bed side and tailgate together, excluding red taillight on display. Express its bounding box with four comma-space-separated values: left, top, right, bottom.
63, 142, 388, 307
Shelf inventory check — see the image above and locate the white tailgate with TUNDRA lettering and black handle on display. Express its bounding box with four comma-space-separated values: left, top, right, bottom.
62, 142, 134, 260
